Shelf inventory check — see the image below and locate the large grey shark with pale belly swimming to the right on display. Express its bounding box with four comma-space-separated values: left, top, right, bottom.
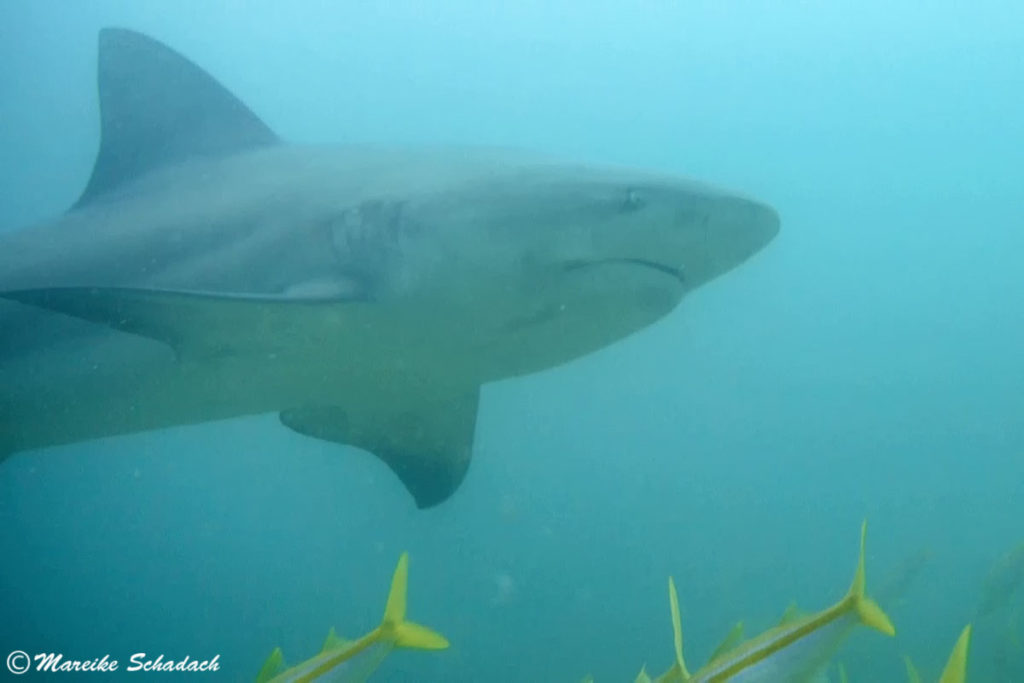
0, 29, 778, 507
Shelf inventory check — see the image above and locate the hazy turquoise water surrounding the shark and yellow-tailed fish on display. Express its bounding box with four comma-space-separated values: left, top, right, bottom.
0, 0, 1024, 682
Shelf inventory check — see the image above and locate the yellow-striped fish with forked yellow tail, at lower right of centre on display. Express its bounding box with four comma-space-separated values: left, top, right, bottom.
651, 522, 892, 683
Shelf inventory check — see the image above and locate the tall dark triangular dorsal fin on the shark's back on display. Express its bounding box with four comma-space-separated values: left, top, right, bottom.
73, 29, 279, 209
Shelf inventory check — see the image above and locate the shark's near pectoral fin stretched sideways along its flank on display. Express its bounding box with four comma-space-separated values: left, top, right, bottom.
0, 287, 353, 359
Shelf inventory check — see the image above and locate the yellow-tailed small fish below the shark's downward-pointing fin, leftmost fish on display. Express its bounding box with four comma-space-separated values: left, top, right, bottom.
256, 553, 449, 683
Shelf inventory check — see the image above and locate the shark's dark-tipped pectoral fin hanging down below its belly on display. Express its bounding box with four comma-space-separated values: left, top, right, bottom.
281, 390, 479, 508
